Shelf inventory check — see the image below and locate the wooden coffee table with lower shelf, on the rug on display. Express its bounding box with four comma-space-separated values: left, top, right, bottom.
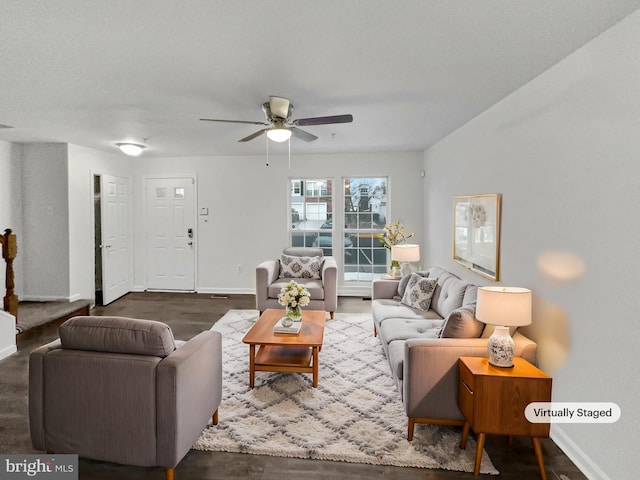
242, 309, 327, 388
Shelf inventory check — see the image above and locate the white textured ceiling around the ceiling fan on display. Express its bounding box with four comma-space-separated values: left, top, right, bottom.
0, 0, 640, 156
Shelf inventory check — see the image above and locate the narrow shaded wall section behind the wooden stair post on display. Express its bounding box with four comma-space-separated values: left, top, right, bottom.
20, 143, 69, 300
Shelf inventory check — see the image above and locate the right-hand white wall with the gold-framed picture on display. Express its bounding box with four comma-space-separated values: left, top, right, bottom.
424, 13, 640, 480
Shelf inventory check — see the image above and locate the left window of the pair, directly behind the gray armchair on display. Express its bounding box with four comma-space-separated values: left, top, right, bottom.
289, 178, 333, 255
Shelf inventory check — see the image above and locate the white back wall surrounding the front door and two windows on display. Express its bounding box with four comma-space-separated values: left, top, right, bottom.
133, 152, 424, 294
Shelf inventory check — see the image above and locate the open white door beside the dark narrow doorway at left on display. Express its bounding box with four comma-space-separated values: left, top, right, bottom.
100, 175, 133, 305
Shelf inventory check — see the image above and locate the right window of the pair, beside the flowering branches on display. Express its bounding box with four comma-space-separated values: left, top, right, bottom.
344, 177, 387, 283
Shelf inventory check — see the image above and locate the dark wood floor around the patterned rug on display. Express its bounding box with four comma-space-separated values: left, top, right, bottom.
0, 292, 586, 480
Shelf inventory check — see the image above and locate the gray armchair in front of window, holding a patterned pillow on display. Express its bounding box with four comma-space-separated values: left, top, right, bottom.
256, 247, 338, 318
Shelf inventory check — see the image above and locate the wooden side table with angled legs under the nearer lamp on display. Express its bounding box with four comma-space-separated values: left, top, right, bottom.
458, 357, 551, 480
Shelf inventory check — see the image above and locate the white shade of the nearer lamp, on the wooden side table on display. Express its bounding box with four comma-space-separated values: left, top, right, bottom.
476, 287, 531, 327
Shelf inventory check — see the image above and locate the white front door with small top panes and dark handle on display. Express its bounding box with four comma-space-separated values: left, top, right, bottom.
145, 177, 195, 291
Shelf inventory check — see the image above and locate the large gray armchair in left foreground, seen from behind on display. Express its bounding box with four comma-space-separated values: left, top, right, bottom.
29, 316, 222, 480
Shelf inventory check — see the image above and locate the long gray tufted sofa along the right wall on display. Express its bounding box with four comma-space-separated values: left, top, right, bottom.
371, 267, 537, 440
